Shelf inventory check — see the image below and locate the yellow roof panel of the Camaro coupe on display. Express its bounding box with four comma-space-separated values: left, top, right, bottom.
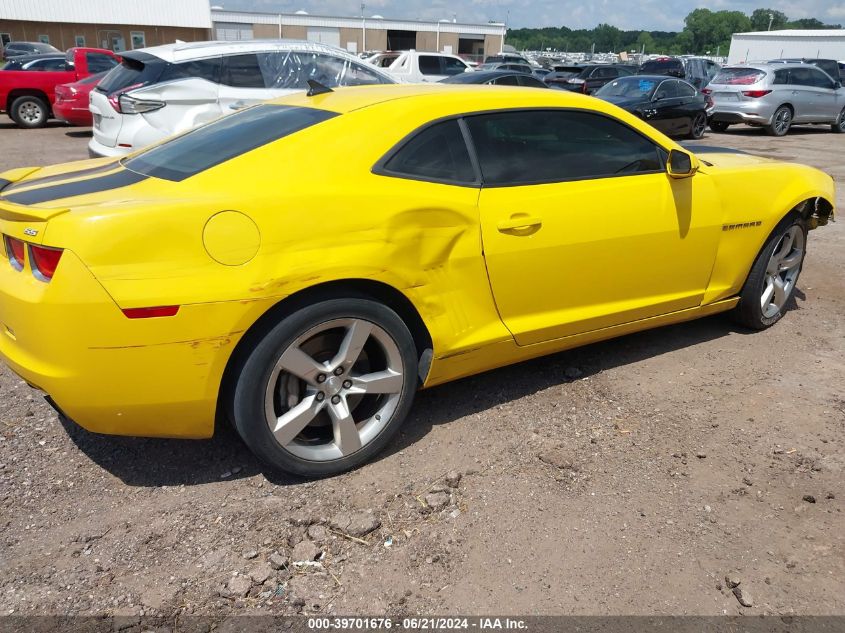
266, 82, 603, 114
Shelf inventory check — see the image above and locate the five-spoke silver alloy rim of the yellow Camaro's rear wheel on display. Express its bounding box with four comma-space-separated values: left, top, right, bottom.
264, 319, 405, 462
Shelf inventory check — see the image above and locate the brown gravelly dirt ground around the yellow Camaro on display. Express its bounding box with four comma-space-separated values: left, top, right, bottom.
0, 117, 845, 616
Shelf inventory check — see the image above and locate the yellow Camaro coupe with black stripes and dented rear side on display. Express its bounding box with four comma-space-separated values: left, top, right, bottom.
0, 85, 834, 476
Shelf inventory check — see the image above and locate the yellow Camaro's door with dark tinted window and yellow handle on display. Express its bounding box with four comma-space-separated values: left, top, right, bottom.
472, 109, 721, 345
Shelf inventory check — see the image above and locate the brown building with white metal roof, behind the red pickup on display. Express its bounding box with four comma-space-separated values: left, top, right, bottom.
0, 0, 211, 52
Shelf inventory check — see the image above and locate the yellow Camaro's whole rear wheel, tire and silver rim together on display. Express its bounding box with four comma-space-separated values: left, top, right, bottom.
230, 298, 417, 477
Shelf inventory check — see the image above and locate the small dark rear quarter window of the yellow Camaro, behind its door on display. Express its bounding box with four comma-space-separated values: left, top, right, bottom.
383, 119, 475, 184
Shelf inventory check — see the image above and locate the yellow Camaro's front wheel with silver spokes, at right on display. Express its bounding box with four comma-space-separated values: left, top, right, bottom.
734, 214, 807, 330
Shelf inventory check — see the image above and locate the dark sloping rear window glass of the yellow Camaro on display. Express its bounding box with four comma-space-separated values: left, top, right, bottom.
123, 105, 337, 182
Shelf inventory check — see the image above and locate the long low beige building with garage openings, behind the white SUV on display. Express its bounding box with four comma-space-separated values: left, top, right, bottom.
211, 9, 505, 61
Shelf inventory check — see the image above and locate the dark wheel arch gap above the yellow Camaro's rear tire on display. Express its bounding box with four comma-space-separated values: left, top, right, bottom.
218, 279, 434, 410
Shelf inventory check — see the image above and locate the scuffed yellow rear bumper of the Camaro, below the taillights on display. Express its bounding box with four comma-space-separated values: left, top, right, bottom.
0, 248, 243, 438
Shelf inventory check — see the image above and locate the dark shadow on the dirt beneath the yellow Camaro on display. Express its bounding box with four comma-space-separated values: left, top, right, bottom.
59, 304, 804, 487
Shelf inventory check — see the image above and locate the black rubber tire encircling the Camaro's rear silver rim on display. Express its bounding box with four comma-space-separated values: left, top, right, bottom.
229, 298, 419, 477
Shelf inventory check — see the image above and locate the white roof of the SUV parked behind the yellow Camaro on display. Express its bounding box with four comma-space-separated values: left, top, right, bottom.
127, 40, 364, 63
